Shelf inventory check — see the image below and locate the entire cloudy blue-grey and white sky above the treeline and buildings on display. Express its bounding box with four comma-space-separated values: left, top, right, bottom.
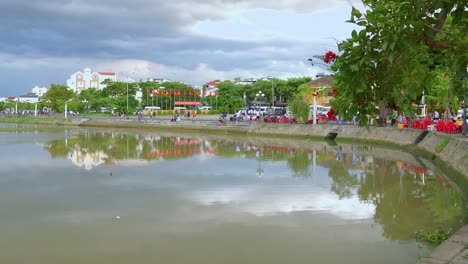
0, 0, 362, 97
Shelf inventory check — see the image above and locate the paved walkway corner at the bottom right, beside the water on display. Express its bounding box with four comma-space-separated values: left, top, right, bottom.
417, 225, 468, 264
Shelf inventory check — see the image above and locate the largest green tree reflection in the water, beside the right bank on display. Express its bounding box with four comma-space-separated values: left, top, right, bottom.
358, 160, 461, 240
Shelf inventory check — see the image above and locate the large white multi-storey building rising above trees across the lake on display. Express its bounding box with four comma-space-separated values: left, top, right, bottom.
67, 68, 117, 93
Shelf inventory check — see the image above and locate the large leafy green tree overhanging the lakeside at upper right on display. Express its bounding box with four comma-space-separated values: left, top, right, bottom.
331, 0, 468, 123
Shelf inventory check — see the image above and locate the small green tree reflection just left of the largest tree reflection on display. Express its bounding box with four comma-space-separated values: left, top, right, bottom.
328, 161, 359, 200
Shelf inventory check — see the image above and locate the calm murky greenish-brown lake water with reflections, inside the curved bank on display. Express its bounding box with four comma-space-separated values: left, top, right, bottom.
0, 127, 463, 264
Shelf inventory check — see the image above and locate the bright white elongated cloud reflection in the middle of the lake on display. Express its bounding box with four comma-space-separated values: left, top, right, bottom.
191, 187, 375, 220
